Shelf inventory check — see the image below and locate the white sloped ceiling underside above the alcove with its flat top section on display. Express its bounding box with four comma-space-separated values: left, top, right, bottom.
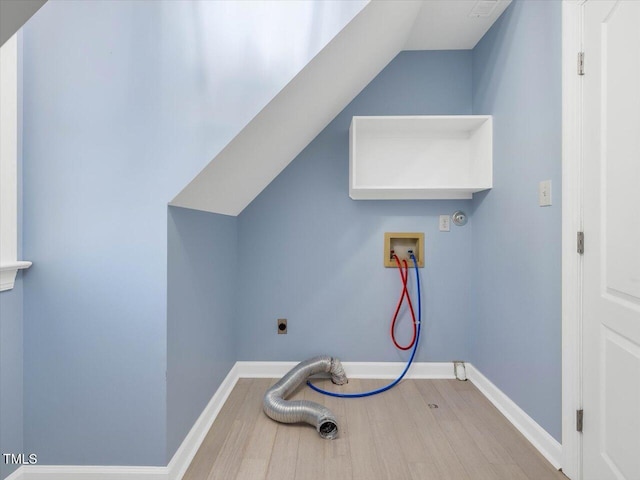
171, 0, 511, 216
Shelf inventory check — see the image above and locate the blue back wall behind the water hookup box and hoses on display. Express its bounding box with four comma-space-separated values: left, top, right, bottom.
237, 51, 472, 361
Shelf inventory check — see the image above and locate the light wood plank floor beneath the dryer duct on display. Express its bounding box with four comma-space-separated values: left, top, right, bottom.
183, 379, 567, 480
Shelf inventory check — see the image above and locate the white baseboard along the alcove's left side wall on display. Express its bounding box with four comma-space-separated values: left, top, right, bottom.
167, 362, 240, 480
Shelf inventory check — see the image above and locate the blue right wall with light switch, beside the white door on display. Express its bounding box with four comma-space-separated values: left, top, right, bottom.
469, 1, 562, 441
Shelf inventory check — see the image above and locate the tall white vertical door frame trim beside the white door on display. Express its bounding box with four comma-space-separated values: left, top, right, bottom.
562, 0, 584, 480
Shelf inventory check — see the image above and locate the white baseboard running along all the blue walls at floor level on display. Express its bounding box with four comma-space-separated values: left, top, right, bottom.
5, 362, 562, 480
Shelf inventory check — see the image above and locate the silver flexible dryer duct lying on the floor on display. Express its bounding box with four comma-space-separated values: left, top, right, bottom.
262, 356, 349, 439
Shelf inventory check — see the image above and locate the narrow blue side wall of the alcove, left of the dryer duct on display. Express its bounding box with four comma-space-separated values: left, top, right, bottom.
167, 207, 238, 462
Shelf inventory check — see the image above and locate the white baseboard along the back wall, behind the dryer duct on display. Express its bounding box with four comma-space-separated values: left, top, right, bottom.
236, 362, 455, 379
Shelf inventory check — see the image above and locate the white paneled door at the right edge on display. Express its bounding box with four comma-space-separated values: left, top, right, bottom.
582, 0, 640, 480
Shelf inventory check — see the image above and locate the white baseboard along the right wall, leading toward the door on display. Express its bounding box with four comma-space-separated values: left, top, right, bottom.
465, 363, 562, 469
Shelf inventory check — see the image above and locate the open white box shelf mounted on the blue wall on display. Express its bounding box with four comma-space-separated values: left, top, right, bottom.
349, 115, 493, 200
